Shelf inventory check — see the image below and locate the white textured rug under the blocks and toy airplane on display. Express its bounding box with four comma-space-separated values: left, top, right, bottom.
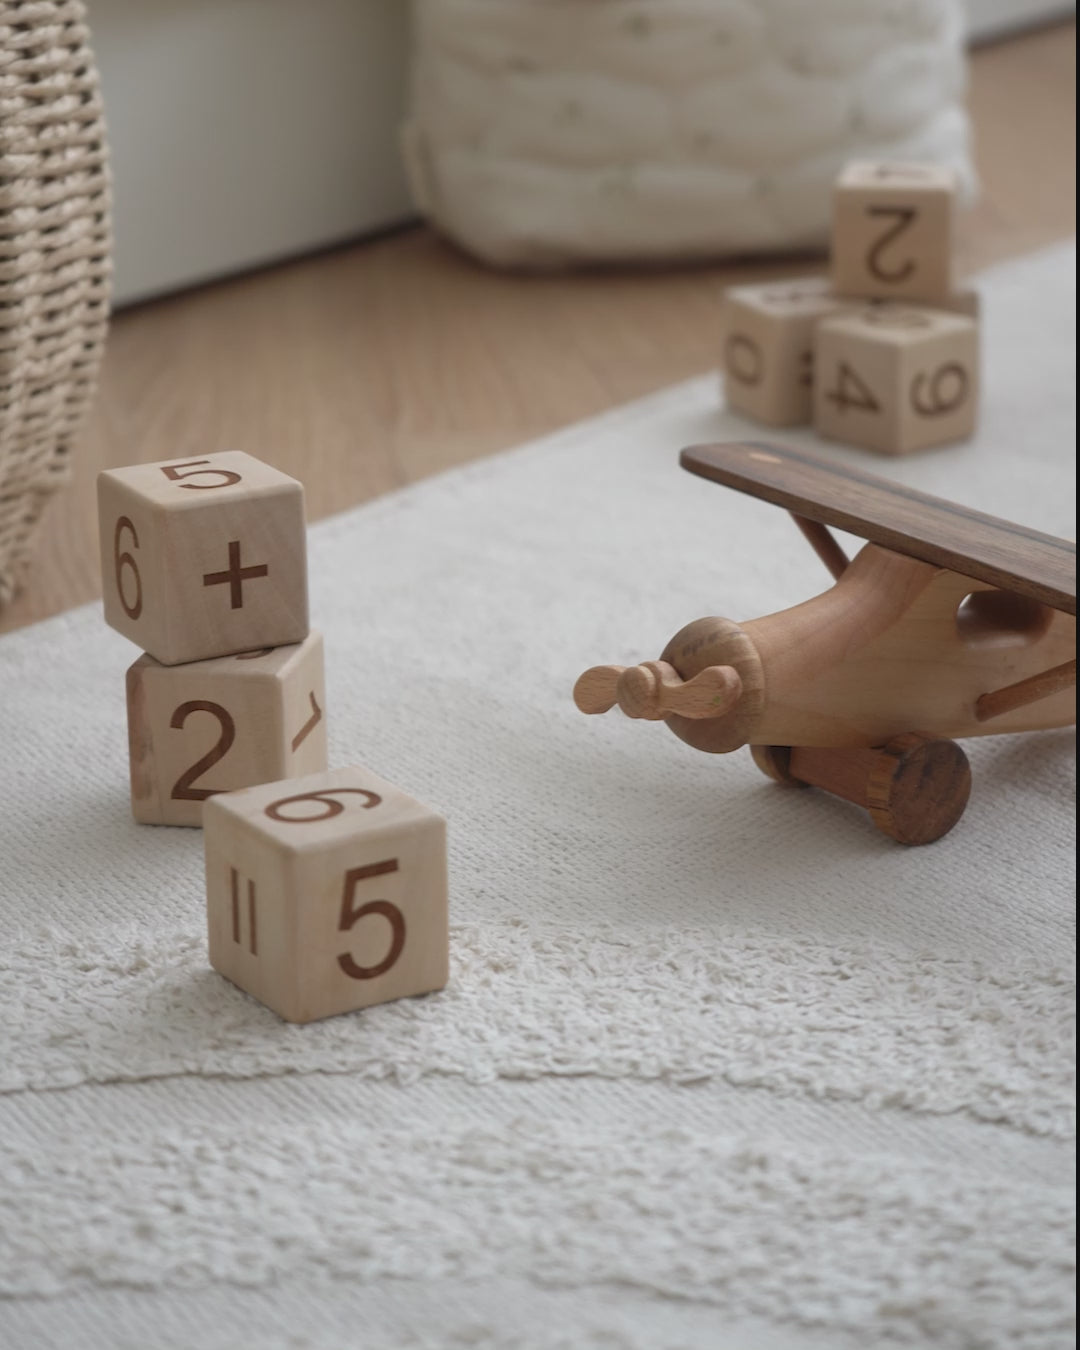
0, 250, 1075, 1350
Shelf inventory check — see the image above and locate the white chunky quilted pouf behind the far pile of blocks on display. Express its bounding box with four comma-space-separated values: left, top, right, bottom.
402, 0, 972, 266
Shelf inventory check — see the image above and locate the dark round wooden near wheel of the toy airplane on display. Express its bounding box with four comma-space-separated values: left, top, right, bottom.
867, 733, 971, 844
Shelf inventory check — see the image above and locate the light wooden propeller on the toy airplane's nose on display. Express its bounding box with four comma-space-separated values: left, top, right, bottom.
574, 662, 743, 722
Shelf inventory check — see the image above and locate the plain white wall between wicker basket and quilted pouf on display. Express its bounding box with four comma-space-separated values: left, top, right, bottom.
89, 0, 410, 302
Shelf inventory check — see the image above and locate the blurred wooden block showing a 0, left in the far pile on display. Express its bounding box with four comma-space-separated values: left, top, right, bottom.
724, 277, 851, 427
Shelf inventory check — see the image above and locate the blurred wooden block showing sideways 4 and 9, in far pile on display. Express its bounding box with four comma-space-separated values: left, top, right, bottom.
814, 305, 979, 455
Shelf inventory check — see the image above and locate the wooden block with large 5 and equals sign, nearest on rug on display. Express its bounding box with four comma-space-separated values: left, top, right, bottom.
205, 768, 450, 1022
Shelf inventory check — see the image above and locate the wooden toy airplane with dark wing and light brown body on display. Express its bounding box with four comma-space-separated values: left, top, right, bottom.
574, 444, 1076, 844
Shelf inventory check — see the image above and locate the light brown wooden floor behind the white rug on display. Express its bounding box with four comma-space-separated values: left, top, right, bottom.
0, 24, 1076, 632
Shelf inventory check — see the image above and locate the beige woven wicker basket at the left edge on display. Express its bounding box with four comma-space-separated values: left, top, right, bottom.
0, 0, 109, 605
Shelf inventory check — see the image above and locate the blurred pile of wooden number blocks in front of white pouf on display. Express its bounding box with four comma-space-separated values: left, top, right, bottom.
724, 163, 979, 455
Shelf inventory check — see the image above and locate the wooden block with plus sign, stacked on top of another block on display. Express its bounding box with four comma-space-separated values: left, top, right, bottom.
97, 451, 308, 666
